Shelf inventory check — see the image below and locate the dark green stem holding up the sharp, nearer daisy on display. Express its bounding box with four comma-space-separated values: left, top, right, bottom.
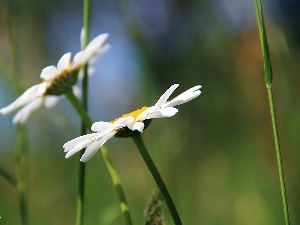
132, 133, 182, 225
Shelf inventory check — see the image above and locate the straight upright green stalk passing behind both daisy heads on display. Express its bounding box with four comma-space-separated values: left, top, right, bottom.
76, 0, 90, 225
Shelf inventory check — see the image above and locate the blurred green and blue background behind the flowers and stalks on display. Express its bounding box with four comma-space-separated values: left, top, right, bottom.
0, 0, 300, 225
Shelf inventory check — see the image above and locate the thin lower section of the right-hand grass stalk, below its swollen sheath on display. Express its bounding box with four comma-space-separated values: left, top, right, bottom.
267, 85, 290, 225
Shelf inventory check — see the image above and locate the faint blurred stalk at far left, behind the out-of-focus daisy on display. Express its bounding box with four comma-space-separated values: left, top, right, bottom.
8, 3, 29, 225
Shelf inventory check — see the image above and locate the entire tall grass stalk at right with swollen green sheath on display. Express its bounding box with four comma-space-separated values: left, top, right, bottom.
254, 0, 290, 225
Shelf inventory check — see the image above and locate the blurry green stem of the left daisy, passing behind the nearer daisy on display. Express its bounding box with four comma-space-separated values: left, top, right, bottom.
65, 91, 132, 225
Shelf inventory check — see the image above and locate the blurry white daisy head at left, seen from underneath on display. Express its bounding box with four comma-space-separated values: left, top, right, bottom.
0, 31, 109, 124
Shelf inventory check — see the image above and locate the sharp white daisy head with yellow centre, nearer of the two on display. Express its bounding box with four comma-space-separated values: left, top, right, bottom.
63, 84, 201, 162
